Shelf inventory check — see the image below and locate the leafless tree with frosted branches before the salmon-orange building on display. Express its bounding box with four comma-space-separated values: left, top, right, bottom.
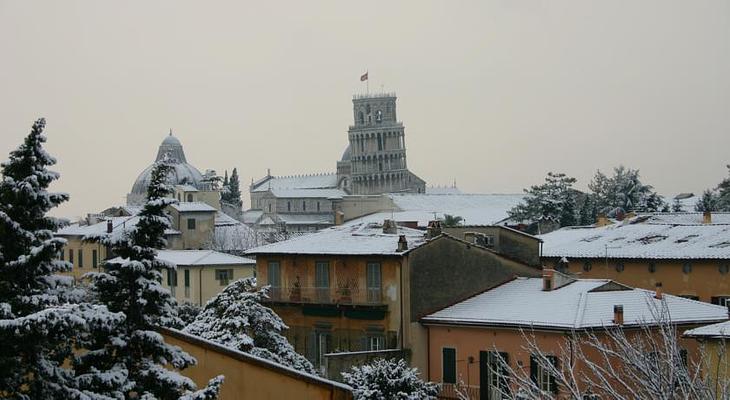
490, 302, 730, 400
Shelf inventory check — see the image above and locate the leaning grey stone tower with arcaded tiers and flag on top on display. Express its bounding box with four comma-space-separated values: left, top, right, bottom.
338, 93, 426, 194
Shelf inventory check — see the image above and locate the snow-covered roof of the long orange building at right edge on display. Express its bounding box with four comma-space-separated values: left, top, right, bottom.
538, 214, 730, 259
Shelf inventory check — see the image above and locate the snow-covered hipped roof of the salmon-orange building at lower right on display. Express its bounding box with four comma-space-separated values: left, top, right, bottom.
422, 278, 728, 330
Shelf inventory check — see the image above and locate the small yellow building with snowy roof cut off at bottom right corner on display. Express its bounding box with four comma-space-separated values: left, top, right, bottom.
684, 321, 730, 398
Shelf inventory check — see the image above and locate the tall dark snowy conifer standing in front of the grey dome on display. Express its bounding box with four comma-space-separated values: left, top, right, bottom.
78, 159, 222, 399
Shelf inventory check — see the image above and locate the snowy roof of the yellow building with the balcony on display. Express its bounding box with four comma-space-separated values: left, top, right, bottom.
246, 223, 426, 255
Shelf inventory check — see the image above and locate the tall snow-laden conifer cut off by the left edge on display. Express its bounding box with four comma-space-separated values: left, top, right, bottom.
0, 119, 124, 399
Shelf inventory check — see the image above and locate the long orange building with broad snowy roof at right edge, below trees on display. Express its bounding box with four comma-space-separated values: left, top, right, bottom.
539, 213, 730, 305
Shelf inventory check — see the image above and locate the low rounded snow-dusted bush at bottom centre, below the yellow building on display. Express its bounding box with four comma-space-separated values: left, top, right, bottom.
342, 359, 439, 400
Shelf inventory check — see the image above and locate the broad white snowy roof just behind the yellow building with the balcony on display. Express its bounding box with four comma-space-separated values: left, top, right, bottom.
348, 193, 524, 226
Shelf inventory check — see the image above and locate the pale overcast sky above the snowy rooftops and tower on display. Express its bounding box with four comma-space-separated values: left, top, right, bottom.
0, 0, 730, 217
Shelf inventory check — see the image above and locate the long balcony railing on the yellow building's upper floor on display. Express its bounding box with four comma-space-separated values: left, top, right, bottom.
269, 287, 383, 305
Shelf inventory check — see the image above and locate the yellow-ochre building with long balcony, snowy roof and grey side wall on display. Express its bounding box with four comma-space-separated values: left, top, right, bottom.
246, 221, 540, 379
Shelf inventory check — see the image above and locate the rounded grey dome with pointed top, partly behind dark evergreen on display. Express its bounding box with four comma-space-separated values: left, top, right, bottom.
130, 132, 203, 199
